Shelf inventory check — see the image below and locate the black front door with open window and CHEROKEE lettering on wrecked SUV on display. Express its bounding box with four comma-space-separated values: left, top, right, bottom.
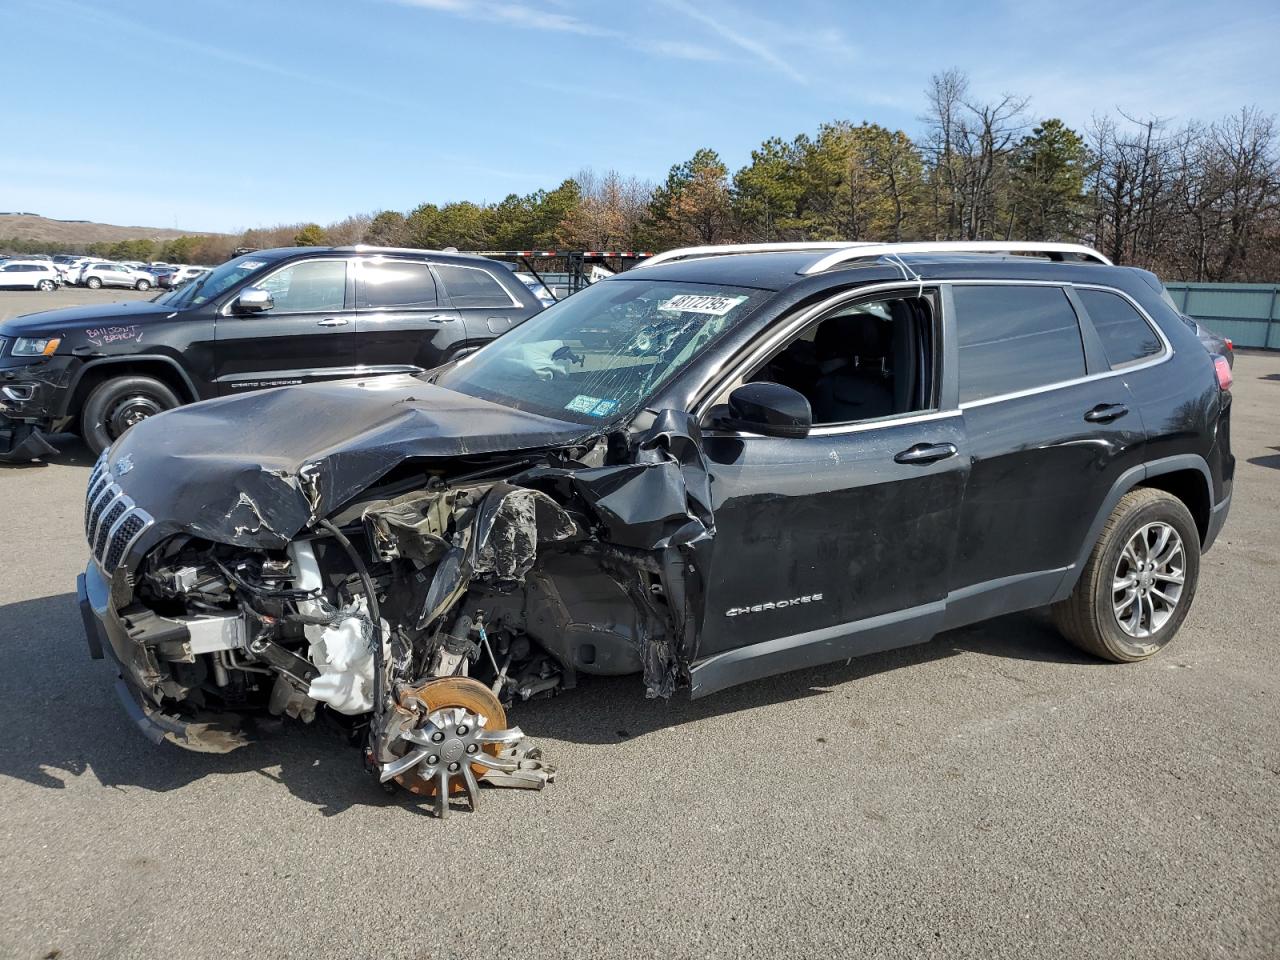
691, 288, 969, 696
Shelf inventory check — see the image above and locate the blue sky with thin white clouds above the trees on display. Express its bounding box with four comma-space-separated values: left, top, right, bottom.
0, 0, 1280, 230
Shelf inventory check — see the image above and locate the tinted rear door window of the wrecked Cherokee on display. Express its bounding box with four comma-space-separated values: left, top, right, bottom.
952, 285, 1084, 403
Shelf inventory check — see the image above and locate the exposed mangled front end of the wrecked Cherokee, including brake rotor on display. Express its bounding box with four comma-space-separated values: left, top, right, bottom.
97, 401, 710, 815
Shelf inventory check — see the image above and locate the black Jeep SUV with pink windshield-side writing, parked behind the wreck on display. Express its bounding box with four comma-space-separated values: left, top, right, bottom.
0, 247, 541, 461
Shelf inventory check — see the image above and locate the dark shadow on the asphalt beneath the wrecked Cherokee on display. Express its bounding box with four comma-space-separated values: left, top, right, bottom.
0, 593, 1097, 817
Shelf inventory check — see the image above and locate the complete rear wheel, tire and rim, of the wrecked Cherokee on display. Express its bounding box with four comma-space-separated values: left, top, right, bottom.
1052, 488, 1199, 663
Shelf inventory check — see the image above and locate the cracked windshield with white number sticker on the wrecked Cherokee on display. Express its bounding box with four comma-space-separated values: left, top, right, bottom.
435, 280, 771, 424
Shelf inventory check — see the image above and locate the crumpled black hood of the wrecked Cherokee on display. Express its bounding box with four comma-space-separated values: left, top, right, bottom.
109, 376, 593, 548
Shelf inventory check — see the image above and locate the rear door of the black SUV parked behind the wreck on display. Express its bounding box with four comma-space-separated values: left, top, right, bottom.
355, 256, 467, 374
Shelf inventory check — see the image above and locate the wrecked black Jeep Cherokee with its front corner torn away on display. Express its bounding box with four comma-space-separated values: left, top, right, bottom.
79, 243, 1234, 814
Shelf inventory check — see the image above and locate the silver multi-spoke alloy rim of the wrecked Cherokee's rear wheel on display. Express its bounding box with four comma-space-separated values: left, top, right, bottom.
1111, 521, 1187, 640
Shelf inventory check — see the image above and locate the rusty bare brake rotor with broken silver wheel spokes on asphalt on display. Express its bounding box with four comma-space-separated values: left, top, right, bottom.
380, 677, 556, 818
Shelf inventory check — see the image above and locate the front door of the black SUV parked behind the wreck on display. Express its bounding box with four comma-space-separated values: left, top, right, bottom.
215, 257, 358, 394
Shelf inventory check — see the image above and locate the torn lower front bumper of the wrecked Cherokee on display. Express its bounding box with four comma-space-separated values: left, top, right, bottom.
76, 561, 250, 754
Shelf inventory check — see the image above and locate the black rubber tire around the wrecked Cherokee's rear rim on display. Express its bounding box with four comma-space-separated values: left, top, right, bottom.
1052, 488, 1201, 663
